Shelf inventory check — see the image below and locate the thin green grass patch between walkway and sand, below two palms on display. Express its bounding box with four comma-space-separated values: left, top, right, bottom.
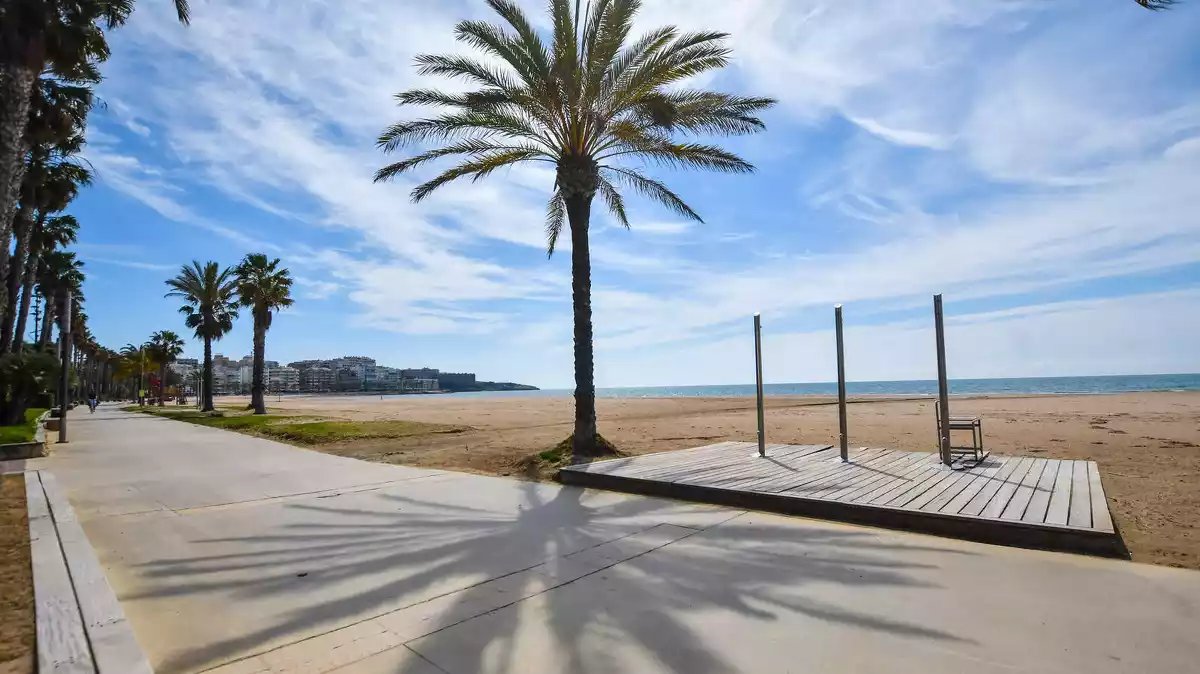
125, 405, 466, 446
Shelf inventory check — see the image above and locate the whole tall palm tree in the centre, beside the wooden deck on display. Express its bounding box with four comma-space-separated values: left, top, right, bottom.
376, 0, 774, 456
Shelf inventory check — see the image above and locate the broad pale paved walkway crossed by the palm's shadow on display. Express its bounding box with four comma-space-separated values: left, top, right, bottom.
37, 408, 1200, 674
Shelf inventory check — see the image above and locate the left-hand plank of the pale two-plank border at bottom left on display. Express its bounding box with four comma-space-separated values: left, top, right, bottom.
25, 471, 96, 674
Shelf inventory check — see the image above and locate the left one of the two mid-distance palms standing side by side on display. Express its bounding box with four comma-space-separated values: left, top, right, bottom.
166, 260, 238, 411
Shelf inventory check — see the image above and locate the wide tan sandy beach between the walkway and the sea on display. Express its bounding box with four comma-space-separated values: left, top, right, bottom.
218, 392, 1200, 568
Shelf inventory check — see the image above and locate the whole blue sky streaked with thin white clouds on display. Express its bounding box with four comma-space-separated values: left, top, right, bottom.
72, 0, 1200, 386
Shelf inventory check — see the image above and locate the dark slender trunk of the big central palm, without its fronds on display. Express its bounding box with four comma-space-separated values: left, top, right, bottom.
566, 192, 600, 457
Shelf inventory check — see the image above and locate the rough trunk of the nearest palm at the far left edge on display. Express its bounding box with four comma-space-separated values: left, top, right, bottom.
0, 60, 40, 309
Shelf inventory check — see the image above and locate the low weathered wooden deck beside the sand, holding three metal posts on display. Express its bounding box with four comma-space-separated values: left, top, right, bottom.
559, 443, 1128, 558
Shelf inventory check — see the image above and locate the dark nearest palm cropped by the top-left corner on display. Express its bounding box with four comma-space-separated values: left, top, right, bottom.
0, 0, 188, 285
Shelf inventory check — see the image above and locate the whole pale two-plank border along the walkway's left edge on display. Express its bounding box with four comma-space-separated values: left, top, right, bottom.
25, 470, 154, 674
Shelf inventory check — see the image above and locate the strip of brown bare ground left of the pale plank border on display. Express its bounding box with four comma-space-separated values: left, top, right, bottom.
0, 472, 37, 674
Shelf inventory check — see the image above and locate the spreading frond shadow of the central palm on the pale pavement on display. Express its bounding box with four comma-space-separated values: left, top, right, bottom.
138, 483, 971, 674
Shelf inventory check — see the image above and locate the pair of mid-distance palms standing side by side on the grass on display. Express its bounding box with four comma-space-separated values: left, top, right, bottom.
160, 253, 293, 414
